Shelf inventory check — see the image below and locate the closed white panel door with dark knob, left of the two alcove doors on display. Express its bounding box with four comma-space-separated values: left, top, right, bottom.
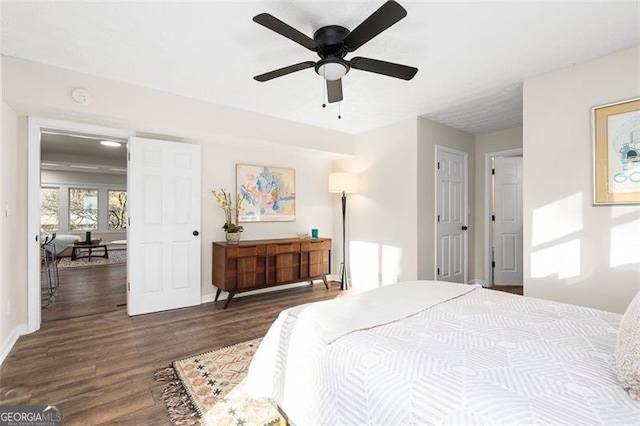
436, 147, 467, 283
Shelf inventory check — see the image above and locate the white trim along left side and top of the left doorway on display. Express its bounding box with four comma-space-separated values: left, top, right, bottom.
27, 117, 135, 333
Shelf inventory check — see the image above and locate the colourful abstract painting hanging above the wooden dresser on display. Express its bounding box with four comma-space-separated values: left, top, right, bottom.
236, 164, 296, 222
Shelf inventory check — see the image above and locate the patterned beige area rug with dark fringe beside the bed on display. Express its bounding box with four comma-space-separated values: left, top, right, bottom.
156, 339, 280, 426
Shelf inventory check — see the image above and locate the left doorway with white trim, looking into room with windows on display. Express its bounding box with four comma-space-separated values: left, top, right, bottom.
28, 118, 133, 332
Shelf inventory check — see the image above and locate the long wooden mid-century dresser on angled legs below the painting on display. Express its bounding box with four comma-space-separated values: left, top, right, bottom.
212, 238, 331, 309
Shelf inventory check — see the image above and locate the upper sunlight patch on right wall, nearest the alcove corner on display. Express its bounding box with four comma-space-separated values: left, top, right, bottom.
531, 192, 583, 246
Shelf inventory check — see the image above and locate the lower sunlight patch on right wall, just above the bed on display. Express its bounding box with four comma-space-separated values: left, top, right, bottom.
531, 240, 580, 279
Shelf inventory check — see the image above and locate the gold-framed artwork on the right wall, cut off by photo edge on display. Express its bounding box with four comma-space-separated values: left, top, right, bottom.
592, 98, 640, 204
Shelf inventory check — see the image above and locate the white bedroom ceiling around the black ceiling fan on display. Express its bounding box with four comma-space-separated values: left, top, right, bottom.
2, 0, 640, 134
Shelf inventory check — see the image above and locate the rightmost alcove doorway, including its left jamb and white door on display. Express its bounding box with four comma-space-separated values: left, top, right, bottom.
485, 149, 523, 287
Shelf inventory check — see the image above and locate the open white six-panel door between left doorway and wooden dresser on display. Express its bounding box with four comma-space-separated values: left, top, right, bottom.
127, 137, 200, 315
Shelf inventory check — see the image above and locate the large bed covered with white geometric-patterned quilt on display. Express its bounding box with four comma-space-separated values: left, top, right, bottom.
246, 281, 640, 426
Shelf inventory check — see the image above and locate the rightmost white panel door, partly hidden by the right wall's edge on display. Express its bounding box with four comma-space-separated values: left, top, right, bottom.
493, 157, 523, 285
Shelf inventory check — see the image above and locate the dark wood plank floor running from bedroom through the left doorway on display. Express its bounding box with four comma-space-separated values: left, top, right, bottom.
0, 265, 524, 425
